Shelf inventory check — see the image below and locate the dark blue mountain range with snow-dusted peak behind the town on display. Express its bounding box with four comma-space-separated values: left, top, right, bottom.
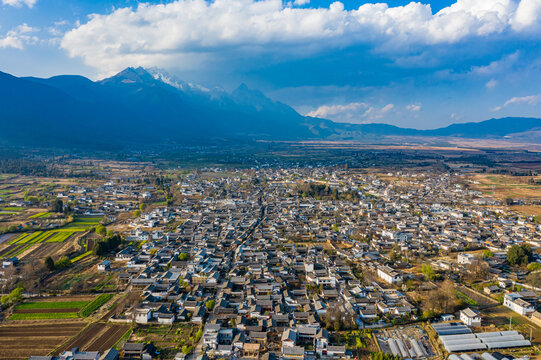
0, 67, 541, 148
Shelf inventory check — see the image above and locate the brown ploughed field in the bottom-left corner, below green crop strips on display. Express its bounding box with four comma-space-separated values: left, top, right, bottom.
0, 321, 85, 360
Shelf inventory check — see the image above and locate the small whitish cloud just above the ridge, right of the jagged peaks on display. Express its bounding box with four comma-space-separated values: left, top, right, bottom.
306, 102, 394, 124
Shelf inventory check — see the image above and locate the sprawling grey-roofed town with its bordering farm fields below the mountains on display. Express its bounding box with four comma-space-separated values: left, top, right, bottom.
0, 163, 541, 360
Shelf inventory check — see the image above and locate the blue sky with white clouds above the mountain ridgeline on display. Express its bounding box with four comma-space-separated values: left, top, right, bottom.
0, 0, 541, 129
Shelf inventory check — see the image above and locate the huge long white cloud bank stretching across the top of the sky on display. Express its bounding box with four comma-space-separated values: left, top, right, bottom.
59, 0, 539, 72
